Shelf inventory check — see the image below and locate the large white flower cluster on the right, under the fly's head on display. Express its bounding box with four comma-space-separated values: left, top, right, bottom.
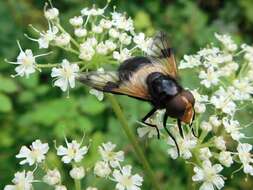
138, 34, 253, 190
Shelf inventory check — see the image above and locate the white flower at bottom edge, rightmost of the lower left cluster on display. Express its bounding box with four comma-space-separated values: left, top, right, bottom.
112, 165, 143, 190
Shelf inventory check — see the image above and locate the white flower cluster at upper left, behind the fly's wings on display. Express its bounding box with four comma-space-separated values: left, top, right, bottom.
7, 2, 151, 95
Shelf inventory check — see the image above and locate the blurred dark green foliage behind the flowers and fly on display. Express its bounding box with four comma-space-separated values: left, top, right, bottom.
0, 0, 253, 190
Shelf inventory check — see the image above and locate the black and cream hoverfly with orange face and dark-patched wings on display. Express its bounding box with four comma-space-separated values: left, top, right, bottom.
78, 32, 195, 154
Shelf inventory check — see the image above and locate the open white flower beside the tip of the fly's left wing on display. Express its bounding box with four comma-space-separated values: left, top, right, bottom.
51, 59, 79, 91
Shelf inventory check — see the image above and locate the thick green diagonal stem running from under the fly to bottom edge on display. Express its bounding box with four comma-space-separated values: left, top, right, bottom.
106, 94, 160, 190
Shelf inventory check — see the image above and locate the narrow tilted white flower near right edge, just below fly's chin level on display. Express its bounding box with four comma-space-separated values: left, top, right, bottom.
222, 117, 245, 141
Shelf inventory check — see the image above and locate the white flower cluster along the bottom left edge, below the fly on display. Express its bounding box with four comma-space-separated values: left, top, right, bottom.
4, 139, 143, 190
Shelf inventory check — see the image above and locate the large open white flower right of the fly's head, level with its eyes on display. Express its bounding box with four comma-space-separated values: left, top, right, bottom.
210, 87, 236, 115
